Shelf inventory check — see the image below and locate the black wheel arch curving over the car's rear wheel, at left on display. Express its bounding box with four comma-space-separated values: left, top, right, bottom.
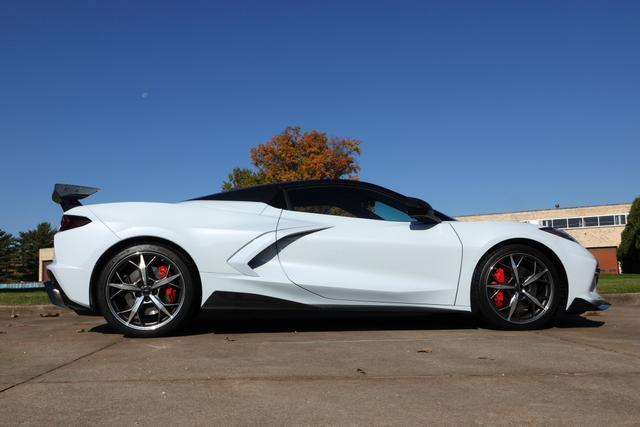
89, 236, 202, 312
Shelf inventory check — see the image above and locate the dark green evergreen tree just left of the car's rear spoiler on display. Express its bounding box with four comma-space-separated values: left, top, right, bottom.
16, 222, 56, 282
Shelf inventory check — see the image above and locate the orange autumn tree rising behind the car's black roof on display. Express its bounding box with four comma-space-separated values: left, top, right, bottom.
222, 126, 360, 190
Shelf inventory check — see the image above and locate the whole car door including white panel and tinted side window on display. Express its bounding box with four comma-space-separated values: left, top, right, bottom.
277, 186, 462, 305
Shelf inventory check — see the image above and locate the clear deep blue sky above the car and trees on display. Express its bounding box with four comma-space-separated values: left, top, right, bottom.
0, 0, 640, 233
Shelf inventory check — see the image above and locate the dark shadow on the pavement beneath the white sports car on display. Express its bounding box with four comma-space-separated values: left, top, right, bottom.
91, 310, 604, 336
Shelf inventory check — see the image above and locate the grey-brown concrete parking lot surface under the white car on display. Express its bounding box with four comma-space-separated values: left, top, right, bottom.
0, 304, 640, 425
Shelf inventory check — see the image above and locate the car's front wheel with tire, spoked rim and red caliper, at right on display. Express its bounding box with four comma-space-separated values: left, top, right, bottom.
471, 244, 563, 330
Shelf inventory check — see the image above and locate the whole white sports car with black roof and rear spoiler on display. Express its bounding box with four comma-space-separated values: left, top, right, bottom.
46, 180, 608, 337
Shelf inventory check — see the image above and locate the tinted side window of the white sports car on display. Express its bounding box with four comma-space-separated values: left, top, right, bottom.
288, 187, 413, 222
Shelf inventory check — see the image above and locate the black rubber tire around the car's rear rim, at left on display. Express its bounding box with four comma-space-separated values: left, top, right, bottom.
96, 244, 201, 338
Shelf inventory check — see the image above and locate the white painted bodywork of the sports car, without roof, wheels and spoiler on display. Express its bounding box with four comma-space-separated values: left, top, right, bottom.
48, 200, 601, 311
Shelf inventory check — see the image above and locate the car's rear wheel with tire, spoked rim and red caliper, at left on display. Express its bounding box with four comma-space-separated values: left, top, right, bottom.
97, 244, 199, 337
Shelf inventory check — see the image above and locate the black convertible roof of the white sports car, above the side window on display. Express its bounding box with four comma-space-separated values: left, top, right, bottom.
193, 179, 406, 208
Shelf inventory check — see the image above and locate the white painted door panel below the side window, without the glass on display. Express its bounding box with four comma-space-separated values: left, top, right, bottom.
278, 210, 462, 305
